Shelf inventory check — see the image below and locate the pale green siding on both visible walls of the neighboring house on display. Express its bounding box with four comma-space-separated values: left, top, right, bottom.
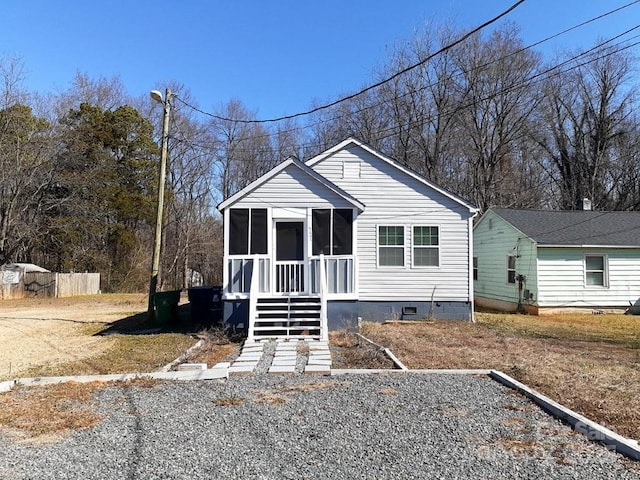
473, 210, 640, 308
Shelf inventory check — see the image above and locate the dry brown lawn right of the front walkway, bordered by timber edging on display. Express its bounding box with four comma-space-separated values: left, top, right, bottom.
363, 314, 640, 439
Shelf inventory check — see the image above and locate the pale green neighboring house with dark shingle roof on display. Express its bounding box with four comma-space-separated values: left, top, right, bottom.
473, 208, 640, 314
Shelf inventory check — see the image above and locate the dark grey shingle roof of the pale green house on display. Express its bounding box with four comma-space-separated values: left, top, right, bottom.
492, 208, 640, 247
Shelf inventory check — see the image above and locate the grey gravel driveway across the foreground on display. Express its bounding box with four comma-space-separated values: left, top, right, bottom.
0, 374, 640, 480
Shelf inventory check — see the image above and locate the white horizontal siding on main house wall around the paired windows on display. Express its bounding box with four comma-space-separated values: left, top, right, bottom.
312, 146, 471, 301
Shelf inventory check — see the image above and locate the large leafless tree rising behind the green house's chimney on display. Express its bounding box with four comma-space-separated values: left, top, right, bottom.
537, 46, 638, 209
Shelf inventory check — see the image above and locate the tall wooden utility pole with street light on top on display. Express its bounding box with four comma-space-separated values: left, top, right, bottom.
147, 88, 171, 321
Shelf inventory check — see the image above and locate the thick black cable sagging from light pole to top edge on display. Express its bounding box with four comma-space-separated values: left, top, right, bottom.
174, 0, 524, 123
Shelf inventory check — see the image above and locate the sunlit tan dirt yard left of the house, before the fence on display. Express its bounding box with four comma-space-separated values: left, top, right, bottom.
0, 294, 196, 380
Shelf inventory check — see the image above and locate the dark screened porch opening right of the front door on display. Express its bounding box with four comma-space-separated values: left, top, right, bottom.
311, 208, 353, 255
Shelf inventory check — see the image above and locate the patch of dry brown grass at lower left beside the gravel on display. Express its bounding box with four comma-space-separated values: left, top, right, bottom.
0, 383, 104, 438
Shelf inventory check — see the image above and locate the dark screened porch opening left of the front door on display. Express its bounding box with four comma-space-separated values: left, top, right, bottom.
229, 208, 267, 255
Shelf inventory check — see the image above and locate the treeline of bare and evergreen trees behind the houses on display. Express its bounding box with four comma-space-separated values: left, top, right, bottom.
0, 24, 640, 291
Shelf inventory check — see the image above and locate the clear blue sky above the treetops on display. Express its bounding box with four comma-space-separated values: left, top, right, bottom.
0, 0, 640, 119
